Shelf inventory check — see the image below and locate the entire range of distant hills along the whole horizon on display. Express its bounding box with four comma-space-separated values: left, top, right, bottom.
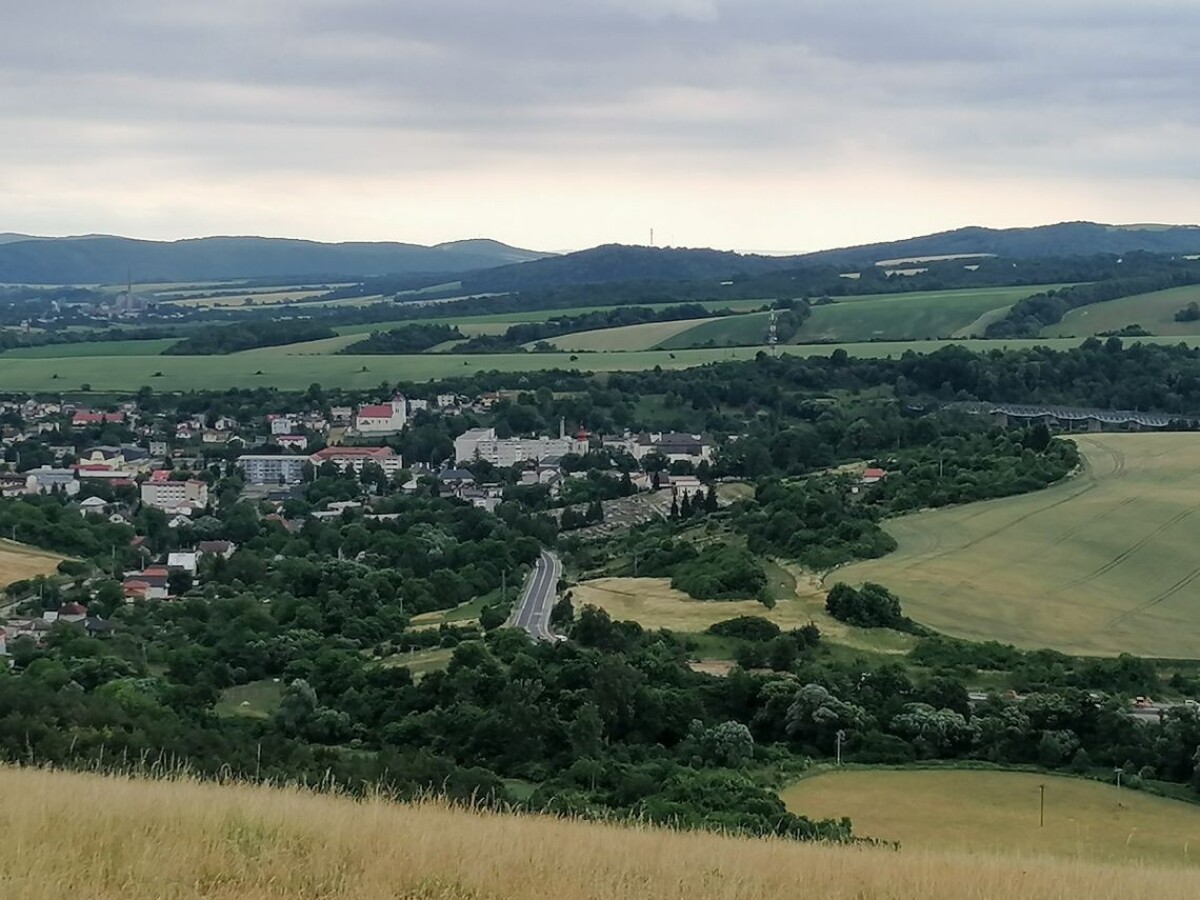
0, 222, 1200, 285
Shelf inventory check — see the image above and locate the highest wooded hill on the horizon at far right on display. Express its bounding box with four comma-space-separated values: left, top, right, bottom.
794, 222, 1200, 265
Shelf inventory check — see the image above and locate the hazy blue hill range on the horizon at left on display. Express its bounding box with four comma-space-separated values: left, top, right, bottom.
0, 234, 546, 284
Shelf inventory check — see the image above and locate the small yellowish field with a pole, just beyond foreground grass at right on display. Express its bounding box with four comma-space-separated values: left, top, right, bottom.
782, 769, 1200, 868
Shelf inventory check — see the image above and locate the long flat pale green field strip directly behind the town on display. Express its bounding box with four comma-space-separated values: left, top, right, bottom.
7, 336, 1200, 392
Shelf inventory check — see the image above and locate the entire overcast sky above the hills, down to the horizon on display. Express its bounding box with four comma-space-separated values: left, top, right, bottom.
0, 0, 1200, 252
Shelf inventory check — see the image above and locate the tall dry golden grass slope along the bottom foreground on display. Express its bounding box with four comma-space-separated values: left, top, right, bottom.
0, 769, 1200, 900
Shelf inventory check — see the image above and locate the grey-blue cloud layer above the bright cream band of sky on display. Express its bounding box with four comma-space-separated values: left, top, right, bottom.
0, 0, 1200, 211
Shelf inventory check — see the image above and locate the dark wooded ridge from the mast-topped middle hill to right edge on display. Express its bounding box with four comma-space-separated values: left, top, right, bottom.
463, 222, 1200, 292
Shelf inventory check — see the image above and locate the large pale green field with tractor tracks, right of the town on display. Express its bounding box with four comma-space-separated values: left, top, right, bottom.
826, 433, 1200, 659
